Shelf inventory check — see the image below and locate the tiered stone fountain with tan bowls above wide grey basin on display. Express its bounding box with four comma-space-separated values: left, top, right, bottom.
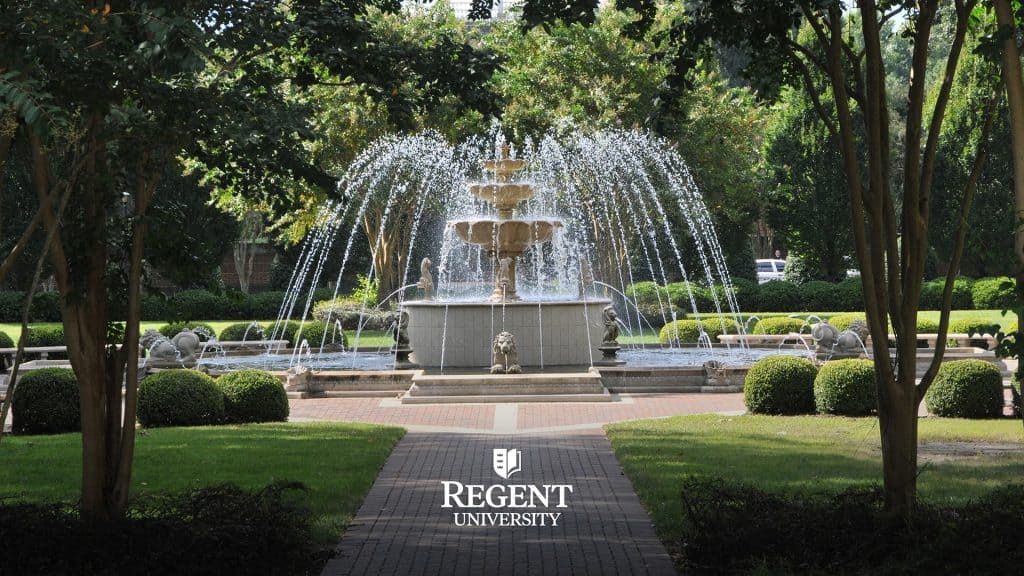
404, 148, 610, 372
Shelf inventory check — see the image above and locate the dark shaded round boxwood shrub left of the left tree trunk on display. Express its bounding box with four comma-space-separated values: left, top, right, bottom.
11, 368, 82, 434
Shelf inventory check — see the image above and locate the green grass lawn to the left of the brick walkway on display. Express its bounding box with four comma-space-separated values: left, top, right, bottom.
0, 423, 404, 545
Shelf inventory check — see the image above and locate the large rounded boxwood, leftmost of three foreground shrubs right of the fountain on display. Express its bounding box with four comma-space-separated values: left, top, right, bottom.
743, 356, 818, 414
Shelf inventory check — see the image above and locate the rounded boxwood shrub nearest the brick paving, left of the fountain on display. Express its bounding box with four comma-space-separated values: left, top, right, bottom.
217, 370, 288, 423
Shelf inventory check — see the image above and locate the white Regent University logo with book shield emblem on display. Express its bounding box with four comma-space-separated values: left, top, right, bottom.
441, 448, 572, 527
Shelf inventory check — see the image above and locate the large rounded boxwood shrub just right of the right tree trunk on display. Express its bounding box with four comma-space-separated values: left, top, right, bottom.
925, 360, 1004, 418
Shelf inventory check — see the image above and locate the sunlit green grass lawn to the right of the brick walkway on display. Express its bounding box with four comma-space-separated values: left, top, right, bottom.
605, 415, 1024, 551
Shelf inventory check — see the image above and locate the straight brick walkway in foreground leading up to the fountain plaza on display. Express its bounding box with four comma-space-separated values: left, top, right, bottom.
324, 430, 675, 576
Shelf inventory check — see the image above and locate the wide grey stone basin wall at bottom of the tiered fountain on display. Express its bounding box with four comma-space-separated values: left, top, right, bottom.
403, 298, 611, 369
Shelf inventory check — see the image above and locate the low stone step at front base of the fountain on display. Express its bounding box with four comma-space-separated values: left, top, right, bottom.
401, 371, 612, 404
